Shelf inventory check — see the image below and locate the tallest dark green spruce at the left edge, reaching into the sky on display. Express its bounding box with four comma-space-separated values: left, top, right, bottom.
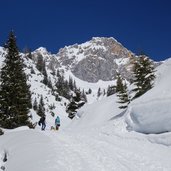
0, 32, 31, 128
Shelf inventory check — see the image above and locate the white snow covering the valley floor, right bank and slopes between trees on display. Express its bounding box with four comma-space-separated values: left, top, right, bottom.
0, 45, 171, 171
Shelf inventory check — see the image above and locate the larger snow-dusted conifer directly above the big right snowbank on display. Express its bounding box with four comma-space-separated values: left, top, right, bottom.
133, 55, 155, 99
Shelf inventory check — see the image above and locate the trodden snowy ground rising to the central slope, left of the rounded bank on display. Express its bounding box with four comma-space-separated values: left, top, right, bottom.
0, 93, 171, 171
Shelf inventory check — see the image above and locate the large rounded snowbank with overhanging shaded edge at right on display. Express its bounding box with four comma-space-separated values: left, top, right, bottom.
126, 58, 171, 133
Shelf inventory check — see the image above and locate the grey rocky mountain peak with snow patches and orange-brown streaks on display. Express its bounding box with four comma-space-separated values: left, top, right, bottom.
57, 37, 135, 83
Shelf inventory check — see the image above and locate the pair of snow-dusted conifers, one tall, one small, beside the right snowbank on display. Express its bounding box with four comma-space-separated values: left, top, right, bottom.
115, 55, 155, 108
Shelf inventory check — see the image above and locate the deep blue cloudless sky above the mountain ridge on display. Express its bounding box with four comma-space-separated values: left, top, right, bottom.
0, 0, 171, 61
